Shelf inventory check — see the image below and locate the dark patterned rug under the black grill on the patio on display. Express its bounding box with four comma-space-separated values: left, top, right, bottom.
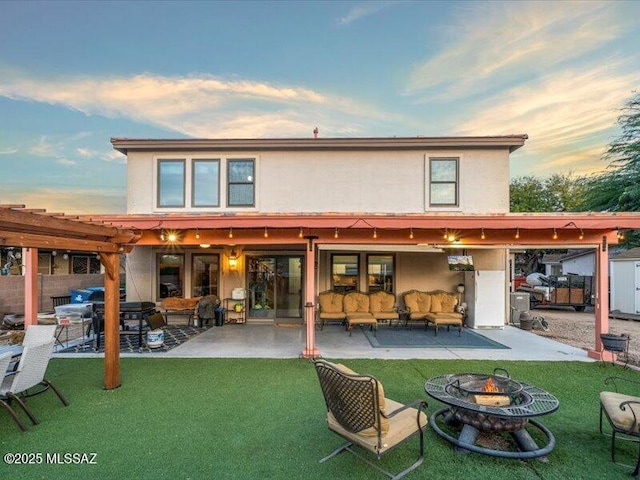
56, 325, 209, 353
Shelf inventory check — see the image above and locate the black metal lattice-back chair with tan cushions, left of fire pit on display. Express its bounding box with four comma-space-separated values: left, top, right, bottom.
314, 360, 428, 479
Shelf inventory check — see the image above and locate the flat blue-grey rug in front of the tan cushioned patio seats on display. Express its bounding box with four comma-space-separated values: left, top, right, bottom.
362, 327, 509, 349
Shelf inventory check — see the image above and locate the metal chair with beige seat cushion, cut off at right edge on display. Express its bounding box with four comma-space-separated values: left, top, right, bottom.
600, 376, 640, 476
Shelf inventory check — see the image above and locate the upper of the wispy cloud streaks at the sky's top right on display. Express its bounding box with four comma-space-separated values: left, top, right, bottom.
407, 2, 622, 100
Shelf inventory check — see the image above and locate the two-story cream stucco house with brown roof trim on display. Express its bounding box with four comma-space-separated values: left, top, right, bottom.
101, 135, 628, 353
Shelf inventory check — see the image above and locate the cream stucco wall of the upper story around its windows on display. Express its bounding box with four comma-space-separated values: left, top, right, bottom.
127, 149, 509, 213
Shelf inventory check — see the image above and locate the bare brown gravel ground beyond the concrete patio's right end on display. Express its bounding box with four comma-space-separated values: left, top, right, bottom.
531, 308, 640, 366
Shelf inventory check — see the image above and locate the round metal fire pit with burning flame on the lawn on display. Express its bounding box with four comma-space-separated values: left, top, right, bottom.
425, 369, 560, 459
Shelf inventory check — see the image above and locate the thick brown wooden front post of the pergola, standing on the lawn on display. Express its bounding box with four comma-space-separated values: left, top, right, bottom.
100, 253, 120, 390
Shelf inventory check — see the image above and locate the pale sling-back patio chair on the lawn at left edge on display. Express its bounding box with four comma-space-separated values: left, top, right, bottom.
0, 339, 69, 431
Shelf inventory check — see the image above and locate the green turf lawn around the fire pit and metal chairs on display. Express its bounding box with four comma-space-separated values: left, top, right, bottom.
0, 358, 639, 480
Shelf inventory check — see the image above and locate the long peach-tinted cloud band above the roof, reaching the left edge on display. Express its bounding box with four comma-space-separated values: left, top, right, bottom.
0, 74, 393, 139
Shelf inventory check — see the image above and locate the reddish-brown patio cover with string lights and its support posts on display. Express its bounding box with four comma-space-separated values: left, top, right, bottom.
90, 212, 640, 358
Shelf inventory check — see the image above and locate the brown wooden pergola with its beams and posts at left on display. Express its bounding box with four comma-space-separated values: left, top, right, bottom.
0, 205, 140, 389
